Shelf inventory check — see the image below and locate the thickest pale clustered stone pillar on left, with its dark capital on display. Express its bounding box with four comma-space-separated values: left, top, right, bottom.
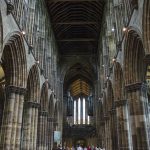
0, 85, 26, 150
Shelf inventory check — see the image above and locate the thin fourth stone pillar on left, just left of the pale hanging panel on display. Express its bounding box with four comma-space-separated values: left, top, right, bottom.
47, 117, 54, 150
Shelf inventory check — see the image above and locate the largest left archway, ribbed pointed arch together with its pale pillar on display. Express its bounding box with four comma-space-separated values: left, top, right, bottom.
0, 32, 27, 149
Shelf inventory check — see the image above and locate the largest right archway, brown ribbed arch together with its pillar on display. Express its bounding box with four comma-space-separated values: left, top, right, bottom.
124, 29, 149, 150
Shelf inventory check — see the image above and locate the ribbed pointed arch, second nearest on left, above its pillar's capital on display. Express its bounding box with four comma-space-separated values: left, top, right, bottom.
26, 65, 40, 103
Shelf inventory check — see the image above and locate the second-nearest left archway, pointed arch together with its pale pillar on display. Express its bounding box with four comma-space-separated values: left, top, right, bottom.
21, 65, 40, 149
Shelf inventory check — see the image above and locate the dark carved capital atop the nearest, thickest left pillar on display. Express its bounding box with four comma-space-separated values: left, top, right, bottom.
5, 85, 27, 95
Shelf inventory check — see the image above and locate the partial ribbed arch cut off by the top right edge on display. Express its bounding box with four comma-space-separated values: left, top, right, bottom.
143, 0, 150, 55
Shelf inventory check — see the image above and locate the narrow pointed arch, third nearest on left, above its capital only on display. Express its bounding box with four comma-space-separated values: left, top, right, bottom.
40, 82, 49, 111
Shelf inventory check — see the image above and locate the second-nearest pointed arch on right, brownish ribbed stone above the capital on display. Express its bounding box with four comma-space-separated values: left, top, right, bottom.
113, 62, 124, 100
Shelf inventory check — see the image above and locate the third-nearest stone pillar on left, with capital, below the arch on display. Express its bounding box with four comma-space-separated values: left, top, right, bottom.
37, 111, 49, 150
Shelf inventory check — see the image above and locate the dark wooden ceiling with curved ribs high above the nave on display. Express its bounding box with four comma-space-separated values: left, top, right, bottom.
46, 0, 104, 55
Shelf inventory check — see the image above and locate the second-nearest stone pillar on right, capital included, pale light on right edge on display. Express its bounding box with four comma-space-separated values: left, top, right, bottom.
115, 100, 133, 150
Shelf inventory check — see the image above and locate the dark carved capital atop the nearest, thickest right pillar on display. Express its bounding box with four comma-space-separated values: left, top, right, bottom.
125, 82, 147, 92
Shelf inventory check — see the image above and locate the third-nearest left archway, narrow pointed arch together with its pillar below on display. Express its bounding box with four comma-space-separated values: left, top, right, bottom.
37, 82, 49, 150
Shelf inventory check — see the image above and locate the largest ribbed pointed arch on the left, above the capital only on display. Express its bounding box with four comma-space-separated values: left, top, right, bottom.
1, 32, 27, 88
